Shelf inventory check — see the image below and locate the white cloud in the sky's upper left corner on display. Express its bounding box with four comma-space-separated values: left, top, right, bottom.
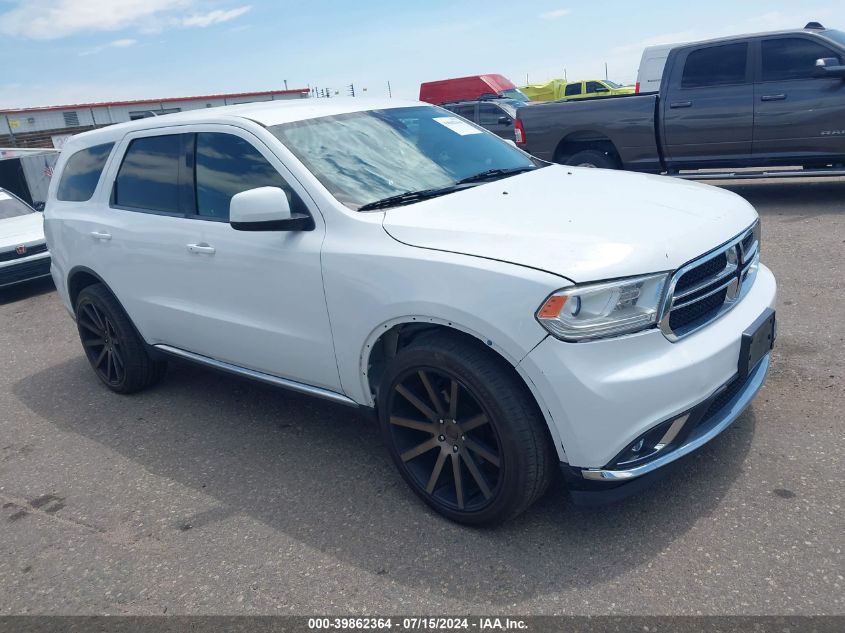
0, 0, 251, 41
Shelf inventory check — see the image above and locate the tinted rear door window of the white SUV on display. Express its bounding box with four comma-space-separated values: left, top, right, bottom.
114, 134, 190, 213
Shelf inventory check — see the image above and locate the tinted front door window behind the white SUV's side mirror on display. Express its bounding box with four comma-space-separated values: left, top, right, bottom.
196, 132, 307, 220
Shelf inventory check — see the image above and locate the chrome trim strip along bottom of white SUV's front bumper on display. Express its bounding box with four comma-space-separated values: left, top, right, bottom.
581, 354, 771, 483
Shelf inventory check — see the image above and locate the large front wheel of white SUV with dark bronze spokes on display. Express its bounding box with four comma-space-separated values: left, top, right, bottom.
378, 332, 557, 525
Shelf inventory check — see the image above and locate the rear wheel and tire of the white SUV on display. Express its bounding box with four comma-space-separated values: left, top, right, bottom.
75, 284, 167, 394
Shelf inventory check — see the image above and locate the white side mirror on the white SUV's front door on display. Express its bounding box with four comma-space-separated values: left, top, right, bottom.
229, 187, 314, 231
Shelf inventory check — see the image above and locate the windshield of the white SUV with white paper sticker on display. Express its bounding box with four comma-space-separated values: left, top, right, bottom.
270, 106, 537, 209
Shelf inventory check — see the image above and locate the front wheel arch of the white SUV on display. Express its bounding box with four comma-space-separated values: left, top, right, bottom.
360, 315, 566, 462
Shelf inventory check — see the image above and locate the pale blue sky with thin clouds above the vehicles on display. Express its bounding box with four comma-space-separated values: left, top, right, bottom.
0, 0, 845, 108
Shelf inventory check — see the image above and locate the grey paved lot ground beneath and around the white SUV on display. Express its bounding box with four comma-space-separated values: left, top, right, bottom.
0, 180, 845, 615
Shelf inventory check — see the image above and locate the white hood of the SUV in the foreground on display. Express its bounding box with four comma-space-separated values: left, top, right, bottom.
384, 165, 757, 283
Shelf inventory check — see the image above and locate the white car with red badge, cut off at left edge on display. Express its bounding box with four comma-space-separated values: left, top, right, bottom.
0, 188, 50, 288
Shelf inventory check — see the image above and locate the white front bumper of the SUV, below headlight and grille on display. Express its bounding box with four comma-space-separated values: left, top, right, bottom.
520, 265, 777, 470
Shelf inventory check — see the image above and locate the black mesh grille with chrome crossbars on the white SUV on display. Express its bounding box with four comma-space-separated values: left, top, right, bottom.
658, 220, 760, 342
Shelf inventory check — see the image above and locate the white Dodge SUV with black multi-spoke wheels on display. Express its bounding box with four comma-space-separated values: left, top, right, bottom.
45, 99, 775, 524
